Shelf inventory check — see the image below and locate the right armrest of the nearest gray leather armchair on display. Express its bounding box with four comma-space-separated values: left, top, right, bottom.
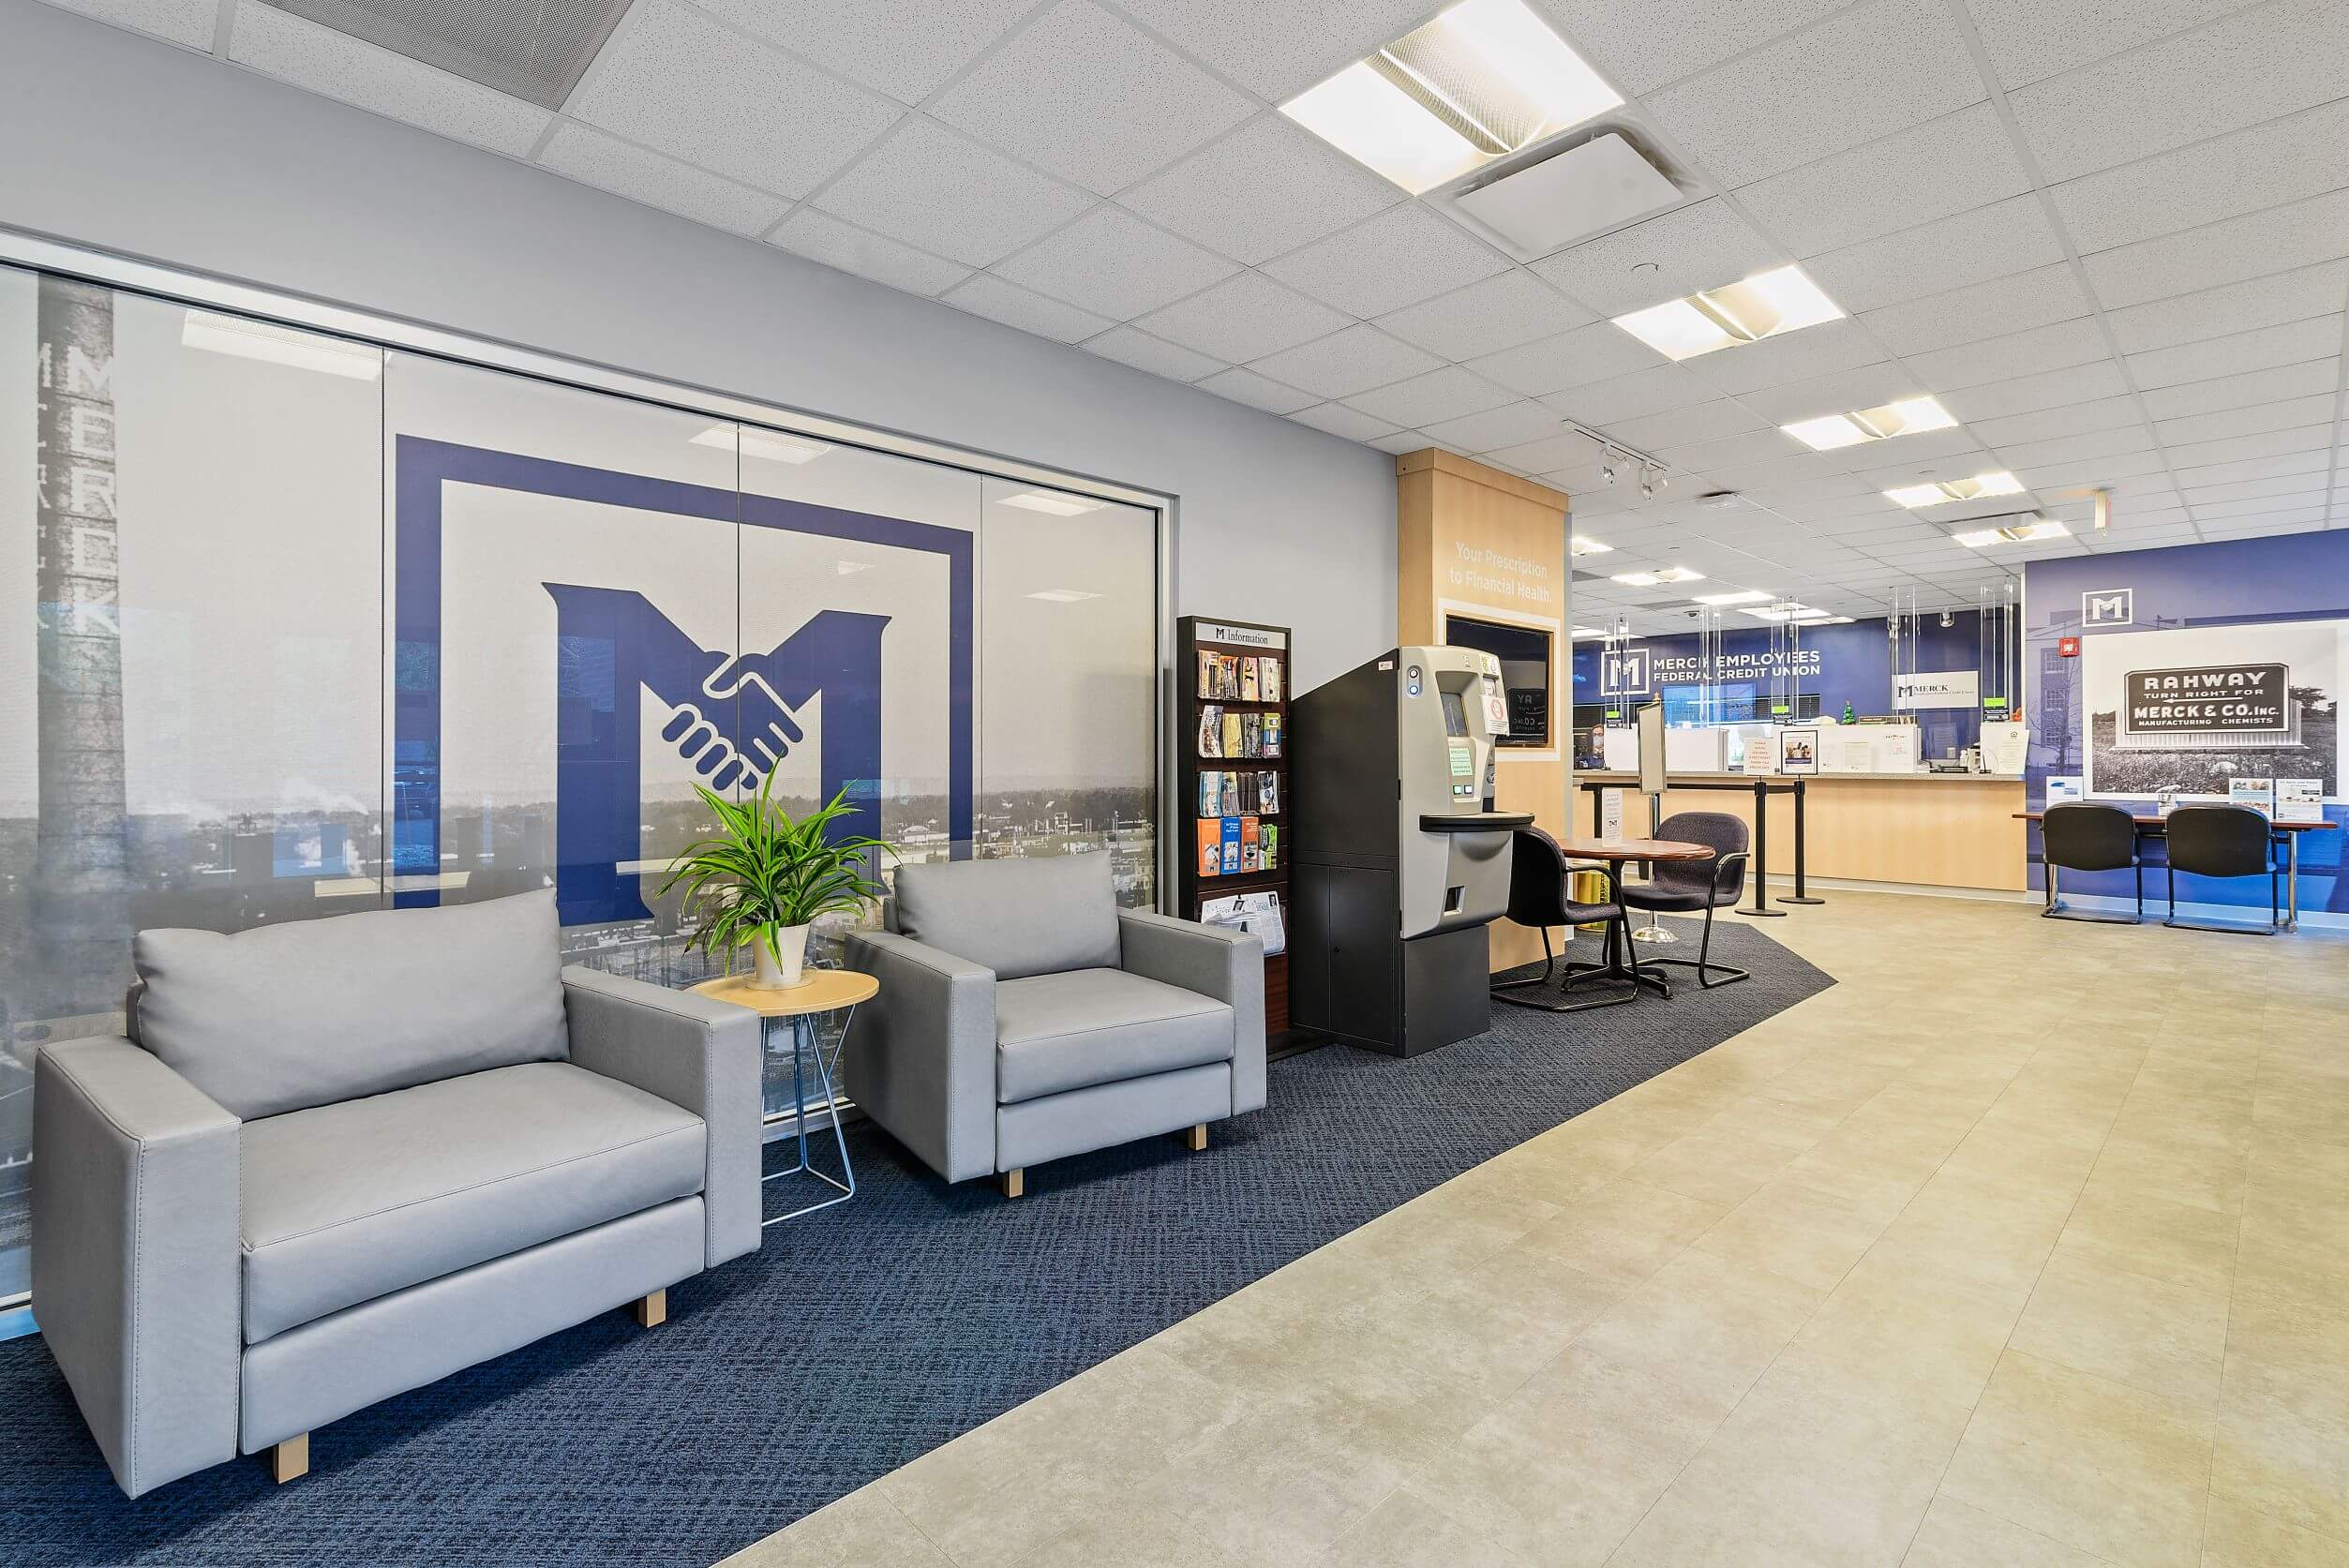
563, 964, 766, 1267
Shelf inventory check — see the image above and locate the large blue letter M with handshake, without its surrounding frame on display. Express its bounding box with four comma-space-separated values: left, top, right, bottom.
545, 582, 888, 925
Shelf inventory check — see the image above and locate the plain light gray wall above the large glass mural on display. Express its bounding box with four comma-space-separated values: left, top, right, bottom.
0, 0, 1396, 688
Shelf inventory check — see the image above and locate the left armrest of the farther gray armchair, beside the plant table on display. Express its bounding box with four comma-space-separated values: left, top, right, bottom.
841, 932, 996, 1181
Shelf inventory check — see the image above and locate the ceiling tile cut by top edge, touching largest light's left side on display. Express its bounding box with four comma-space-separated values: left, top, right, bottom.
1120, 0, 1435, 103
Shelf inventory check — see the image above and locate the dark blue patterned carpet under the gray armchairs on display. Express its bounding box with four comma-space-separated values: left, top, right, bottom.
0, 920, 1833, 1568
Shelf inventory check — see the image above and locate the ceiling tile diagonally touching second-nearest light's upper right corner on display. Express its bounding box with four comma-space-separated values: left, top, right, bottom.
1738, 103, 2032, 256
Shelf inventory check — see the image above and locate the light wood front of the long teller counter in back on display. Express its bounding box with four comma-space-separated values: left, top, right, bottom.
1574, 772, 2029, 894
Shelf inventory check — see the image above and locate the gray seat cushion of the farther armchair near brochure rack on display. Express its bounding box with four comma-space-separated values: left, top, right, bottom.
996, 969, 1231, 1106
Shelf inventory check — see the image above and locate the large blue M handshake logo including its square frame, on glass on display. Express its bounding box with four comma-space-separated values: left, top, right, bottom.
390, 437, 975, 925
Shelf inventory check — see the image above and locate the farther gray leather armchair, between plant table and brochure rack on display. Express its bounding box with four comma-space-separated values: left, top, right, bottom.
844, 855, 1264, 1197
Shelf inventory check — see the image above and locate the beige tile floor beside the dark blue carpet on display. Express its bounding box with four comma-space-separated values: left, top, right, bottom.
730, 892, 2349, 1568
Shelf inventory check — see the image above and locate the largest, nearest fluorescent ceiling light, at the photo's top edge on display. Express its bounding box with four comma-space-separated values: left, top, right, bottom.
1280, 0, 1623, 195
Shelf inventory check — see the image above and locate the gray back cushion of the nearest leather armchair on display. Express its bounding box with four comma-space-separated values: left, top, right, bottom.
129, 889, 568, 1122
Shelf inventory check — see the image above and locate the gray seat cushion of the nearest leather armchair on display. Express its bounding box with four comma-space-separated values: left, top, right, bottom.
242, 1061, 705, 1343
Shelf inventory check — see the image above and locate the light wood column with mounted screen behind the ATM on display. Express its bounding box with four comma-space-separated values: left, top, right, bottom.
1396, 448, 1574, 972
